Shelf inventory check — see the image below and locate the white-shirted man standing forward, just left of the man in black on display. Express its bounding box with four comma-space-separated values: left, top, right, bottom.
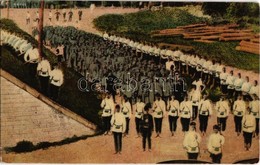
110, 105, 126, 154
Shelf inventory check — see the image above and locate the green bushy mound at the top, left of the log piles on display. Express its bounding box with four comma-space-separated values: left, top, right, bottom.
93, 8, 207, 34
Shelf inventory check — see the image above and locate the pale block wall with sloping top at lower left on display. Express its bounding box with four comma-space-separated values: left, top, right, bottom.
1, 70, 95, 147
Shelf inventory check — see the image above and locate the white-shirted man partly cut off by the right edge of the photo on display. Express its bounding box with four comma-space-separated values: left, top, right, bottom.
249, 94, 260, 137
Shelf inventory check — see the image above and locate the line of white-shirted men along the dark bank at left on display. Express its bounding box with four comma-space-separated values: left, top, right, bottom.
1, 30, 64, 100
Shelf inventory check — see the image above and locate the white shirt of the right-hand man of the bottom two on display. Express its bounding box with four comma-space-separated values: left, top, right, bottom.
207, 132, 225, 154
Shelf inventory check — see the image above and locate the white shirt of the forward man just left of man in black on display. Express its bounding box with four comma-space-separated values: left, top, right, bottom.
110, 112, 126, 133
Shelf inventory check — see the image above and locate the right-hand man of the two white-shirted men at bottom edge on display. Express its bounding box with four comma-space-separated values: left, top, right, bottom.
207, 125, 225, 163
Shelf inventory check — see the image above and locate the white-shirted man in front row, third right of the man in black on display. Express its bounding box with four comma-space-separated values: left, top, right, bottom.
180, 95, 193, 132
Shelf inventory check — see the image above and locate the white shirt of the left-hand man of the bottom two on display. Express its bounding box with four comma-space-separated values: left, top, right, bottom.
183, 130, 201, 153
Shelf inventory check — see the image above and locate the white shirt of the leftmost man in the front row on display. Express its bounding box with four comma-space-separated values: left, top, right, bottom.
100, 97, 115, 118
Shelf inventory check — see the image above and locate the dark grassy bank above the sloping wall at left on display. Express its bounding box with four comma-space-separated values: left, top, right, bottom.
0, 19, 102, 127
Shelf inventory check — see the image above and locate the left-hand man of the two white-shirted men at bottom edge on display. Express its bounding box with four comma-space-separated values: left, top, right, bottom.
183, 122, 201, 159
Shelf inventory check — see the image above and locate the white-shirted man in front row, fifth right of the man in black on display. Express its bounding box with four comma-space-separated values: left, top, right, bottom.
216, 95, 230, 131
